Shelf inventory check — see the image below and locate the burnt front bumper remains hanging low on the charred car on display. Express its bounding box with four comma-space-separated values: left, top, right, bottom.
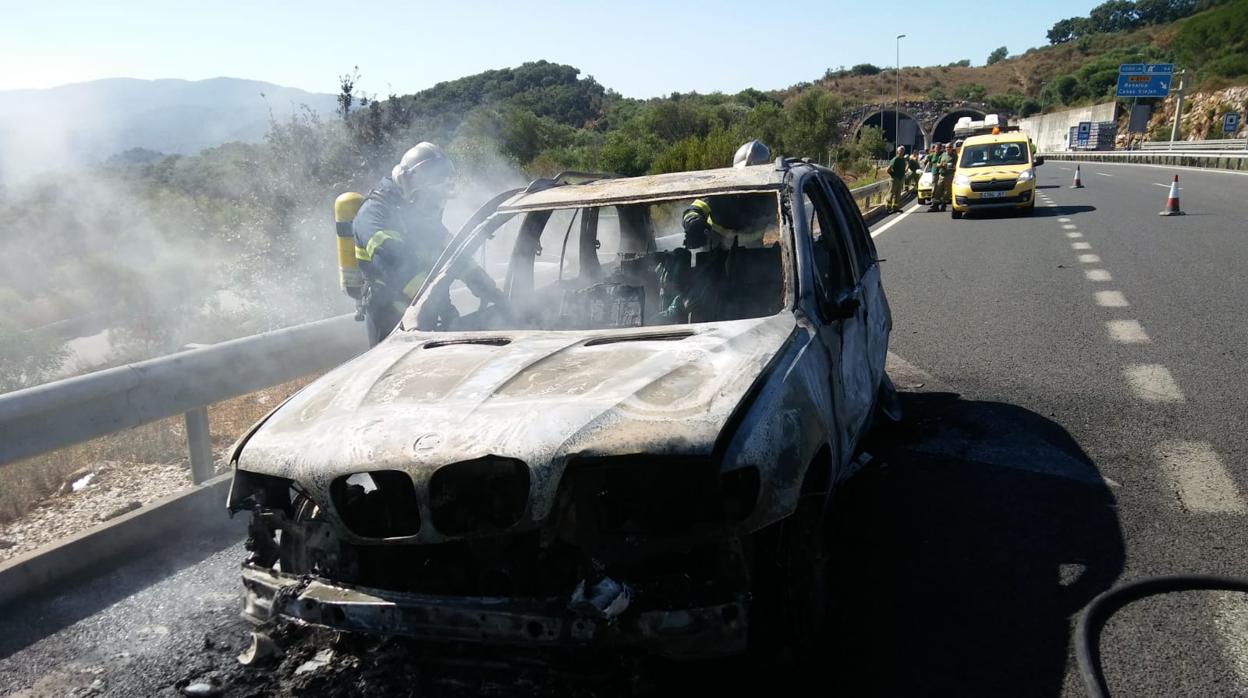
242, 563, 748, 659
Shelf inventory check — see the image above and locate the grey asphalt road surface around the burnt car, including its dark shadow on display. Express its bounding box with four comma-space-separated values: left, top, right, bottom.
0, 162, 1248, 697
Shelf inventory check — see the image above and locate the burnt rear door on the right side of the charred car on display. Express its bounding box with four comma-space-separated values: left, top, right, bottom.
824, 177, 892, 394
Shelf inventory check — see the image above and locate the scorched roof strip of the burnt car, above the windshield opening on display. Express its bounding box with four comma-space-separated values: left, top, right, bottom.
498, 164, 785, 212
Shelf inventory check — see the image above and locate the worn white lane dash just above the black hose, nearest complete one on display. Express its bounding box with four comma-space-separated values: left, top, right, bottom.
1153, 441, 1248, 514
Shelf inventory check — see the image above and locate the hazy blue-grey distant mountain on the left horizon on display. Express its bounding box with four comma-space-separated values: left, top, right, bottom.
0, 77, 336, 184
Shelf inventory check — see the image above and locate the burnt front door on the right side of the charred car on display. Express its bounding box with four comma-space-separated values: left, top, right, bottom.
799, 172, 874, 463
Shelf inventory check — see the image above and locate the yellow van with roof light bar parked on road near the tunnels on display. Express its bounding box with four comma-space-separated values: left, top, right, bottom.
951, 131, 1045, 219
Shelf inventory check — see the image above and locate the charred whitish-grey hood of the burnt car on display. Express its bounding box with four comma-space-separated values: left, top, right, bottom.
238, 312, 796, 486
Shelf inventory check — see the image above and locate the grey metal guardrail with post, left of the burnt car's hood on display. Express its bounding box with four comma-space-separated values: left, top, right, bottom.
0, 315, 367, 483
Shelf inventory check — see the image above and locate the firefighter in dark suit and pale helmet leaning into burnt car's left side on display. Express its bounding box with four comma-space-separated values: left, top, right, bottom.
352, 142, 503, 346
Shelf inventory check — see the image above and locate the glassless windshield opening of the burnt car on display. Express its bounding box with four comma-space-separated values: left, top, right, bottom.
403, 191, 786, 331
